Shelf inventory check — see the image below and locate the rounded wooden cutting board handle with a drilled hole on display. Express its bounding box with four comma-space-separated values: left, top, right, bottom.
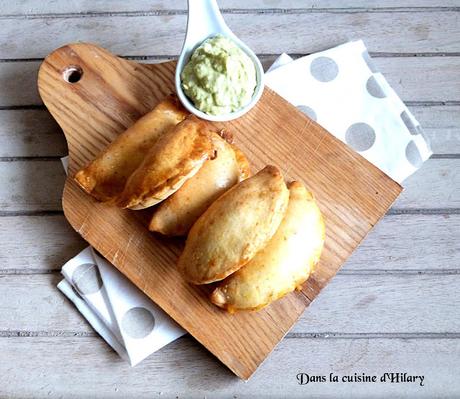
38, 43, 174, 171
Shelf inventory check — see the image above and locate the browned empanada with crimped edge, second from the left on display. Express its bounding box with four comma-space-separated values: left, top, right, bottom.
117, 115, 215, 209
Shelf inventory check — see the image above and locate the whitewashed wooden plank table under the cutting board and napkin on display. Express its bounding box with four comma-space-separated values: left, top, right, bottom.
0, 0, 460, 398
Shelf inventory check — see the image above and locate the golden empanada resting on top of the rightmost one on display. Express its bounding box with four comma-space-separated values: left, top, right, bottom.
178, 166, 289, 284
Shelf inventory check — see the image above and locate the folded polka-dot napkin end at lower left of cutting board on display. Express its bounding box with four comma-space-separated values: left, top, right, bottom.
58, 157, 185, 366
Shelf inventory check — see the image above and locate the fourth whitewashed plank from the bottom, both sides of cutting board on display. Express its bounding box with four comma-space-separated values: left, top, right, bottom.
0, 158, 460, 212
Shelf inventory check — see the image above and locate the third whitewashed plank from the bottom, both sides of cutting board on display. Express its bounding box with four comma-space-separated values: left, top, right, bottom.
0, 214, 460, 276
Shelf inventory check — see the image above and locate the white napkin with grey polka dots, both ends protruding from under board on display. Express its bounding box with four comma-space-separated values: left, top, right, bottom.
58, 41, 431, 365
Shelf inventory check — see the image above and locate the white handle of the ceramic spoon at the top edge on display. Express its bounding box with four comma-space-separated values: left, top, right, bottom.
185, 0, 230, 47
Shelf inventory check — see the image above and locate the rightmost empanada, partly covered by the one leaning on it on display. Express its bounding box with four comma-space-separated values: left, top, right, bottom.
211, 182, 325, 312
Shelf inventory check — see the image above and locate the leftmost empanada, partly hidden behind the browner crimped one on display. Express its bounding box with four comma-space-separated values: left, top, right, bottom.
75, 96, 188, 201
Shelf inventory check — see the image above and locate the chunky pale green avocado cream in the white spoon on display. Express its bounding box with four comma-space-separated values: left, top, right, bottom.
181, 35, 257, 115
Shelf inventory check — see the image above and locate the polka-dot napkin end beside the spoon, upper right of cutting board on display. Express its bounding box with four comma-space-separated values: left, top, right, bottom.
265, 40, 432, 183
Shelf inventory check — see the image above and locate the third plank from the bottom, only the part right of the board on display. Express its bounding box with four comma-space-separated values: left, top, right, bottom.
343, 211, 460, 274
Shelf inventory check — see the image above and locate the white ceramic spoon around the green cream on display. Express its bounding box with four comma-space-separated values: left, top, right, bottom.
175, 0, 264, 122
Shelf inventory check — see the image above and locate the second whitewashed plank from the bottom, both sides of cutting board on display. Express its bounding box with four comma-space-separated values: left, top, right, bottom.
0, 276, 460, 334
